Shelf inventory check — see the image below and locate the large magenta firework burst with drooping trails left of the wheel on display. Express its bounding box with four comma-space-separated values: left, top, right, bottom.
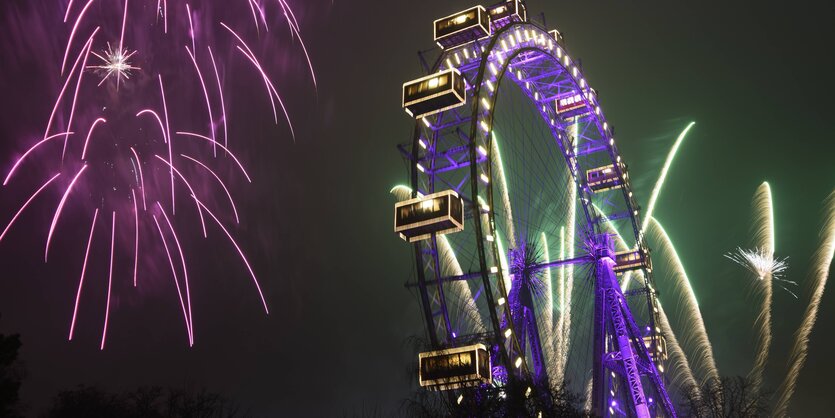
0, 0, 316, 349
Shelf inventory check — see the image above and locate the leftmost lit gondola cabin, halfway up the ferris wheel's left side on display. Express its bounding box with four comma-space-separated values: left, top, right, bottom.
394, 190, 464, 242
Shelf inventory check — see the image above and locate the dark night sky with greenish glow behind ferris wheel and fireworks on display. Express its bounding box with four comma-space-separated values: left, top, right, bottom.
0, 0, 835, 417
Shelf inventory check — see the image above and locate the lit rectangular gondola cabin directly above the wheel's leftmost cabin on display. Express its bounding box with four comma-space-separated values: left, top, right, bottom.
403, 68, 467, 119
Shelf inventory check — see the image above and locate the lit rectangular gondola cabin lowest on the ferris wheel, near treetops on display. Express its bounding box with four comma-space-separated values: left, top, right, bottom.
418, 344, 492, 390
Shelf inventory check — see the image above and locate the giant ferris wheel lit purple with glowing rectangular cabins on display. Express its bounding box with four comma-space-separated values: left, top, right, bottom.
393, 0, 675, 417
